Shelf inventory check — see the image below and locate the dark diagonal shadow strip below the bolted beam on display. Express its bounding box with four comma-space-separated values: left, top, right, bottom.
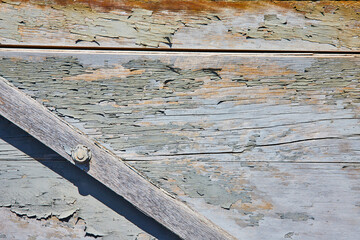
0, 116, 180, 240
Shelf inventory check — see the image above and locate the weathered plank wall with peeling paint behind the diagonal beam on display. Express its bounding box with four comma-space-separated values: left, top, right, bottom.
0, 0, 360, 240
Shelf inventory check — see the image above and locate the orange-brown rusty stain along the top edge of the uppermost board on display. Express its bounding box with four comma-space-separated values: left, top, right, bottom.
16, 0, 360, 12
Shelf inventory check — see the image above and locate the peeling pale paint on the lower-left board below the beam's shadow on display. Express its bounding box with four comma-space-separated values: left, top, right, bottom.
0, 158, 153, 240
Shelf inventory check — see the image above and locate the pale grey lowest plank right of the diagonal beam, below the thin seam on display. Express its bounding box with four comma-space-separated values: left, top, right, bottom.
131, 157, 360, 240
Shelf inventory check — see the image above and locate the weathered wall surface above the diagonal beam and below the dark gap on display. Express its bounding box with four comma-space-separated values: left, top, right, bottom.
0, 50, 360, 239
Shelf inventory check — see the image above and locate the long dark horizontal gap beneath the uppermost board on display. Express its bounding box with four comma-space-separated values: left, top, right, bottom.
0, 44, 360, 54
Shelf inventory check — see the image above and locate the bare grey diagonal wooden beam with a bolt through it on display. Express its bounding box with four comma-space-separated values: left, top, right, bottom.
0, 77, 235, 240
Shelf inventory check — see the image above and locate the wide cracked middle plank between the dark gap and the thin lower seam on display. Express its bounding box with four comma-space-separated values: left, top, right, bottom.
0, 51, 360, 162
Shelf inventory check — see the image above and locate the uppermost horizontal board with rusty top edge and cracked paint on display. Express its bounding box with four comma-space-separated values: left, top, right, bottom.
0, 0, 360, 51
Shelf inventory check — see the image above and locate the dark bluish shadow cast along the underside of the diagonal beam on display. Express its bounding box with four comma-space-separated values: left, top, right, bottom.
0, 117, 177, 240
